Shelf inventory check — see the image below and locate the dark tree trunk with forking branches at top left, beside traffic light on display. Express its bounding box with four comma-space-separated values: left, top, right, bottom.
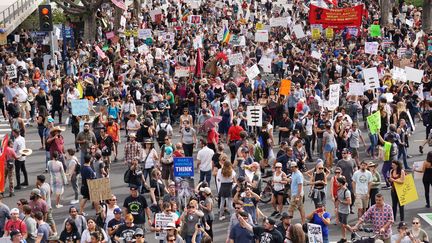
53, 0, 107, 42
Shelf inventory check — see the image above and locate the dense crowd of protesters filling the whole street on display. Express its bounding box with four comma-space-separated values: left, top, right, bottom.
0, 0, 432, 243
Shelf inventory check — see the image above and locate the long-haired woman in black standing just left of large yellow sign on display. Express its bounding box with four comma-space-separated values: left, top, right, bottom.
389, 160, 405, 221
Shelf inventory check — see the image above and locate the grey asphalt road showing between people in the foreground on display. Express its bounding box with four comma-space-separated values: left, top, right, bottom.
0, 116, 432, 242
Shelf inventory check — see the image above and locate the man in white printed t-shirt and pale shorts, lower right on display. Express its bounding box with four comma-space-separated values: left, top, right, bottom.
352, 161, 372, 218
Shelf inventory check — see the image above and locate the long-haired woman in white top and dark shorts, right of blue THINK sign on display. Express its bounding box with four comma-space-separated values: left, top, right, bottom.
216, 160, 236, 220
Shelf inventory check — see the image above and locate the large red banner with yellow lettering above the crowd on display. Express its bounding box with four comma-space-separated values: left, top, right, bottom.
309, 4, 363, 29
